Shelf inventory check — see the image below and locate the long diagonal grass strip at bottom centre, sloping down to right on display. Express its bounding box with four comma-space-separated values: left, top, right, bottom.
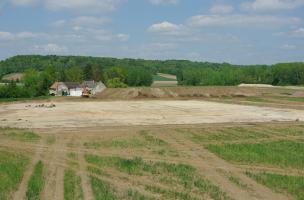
85, 154, 230, 199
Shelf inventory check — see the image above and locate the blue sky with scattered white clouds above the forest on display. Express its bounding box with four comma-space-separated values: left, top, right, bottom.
0, 0, 304, 64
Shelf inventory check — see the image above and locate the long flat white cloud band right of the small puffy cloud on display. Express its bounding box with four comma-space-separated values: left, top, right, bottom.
188, 14, 301, 28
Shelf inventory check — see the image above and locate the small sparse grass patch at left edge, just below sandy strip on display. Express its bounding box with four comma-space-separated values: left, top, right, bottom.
0, 128, 41, 142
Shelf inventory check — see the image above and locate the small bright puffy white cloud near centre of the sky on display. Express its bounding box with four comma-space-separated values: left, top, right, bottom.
148, 21, 186, 35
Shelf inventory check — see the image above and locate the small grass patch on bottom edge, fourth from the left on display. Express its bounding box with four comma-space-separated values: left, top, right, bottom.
90, 176, 117, 200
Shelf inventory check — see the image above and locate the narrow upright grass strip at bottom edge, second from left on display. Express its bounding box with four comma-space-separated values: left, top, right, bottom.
26, 161, 44, 200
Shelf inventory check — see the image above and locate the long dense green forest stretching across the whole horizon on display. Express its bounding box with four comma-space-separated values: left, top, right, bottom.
0, 55, 304, 97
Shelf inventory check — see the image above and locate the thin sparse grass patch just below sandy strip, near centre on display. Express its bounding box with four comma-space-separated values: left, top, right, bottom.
84, 130, 167, 149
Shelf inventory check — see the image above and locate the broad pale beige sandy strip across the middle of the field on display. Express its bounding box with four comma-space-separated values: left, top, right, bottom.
0, 100, 304, 128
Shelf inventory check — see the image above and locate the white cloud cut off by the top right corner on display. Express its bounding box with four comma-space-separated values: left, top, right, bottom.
241, 0, 304, 12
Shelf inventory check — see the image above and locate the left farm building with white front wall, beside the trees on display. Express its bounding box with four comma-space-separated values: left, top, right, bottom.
49, 82, 82, 97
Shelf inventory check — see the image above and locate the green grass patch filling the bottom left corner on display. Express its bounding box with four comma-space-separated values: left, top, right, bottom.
0, 151, 29, 200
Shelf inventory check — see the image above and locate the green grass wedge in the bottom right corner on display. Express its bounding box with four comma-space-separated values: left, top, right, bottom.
246, 172, 304, 200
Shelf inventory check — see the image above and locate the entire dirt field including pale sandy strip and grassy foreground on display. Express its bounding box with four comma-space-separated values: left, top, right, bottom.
0, 88, 304, 200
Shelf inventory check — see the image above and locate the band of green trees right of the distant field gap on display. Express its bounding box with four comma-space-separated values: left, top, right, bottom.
177, 63, 304, 86
